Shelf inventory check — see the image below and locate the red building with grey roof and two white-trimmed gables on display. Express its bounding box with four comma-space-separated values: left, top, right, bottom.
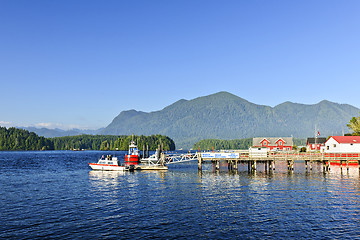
253, 137, 294, 151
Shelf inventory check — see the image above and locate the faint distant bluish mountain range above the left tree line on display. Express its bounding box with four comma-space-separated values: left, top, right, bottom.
21, 127, 103, 138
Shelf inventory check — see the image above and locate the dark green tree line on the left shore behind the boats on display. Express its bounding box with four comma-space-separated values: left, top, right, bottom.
0, 127, 175, 151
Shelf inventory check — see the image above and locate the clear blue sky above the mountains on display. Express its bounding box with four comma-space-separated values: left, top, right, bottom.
0, 0, 360, 129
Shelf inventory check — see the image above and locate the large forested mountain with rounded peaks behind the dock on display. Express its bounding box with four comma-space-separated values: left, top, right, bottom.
100, 92, 360, 148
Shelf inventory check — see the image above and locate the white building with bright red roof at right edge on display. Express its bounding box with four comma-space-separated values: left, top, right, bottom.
321, 136, 360, 153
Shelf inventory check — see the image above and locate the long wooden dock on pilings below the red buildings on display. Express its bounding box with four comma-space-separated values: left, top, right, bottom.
198, 151, 360, 172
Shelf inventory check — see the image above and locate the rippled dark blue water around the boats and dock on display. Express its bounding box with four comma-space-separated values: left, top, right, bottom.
0, 151, 360, 239
